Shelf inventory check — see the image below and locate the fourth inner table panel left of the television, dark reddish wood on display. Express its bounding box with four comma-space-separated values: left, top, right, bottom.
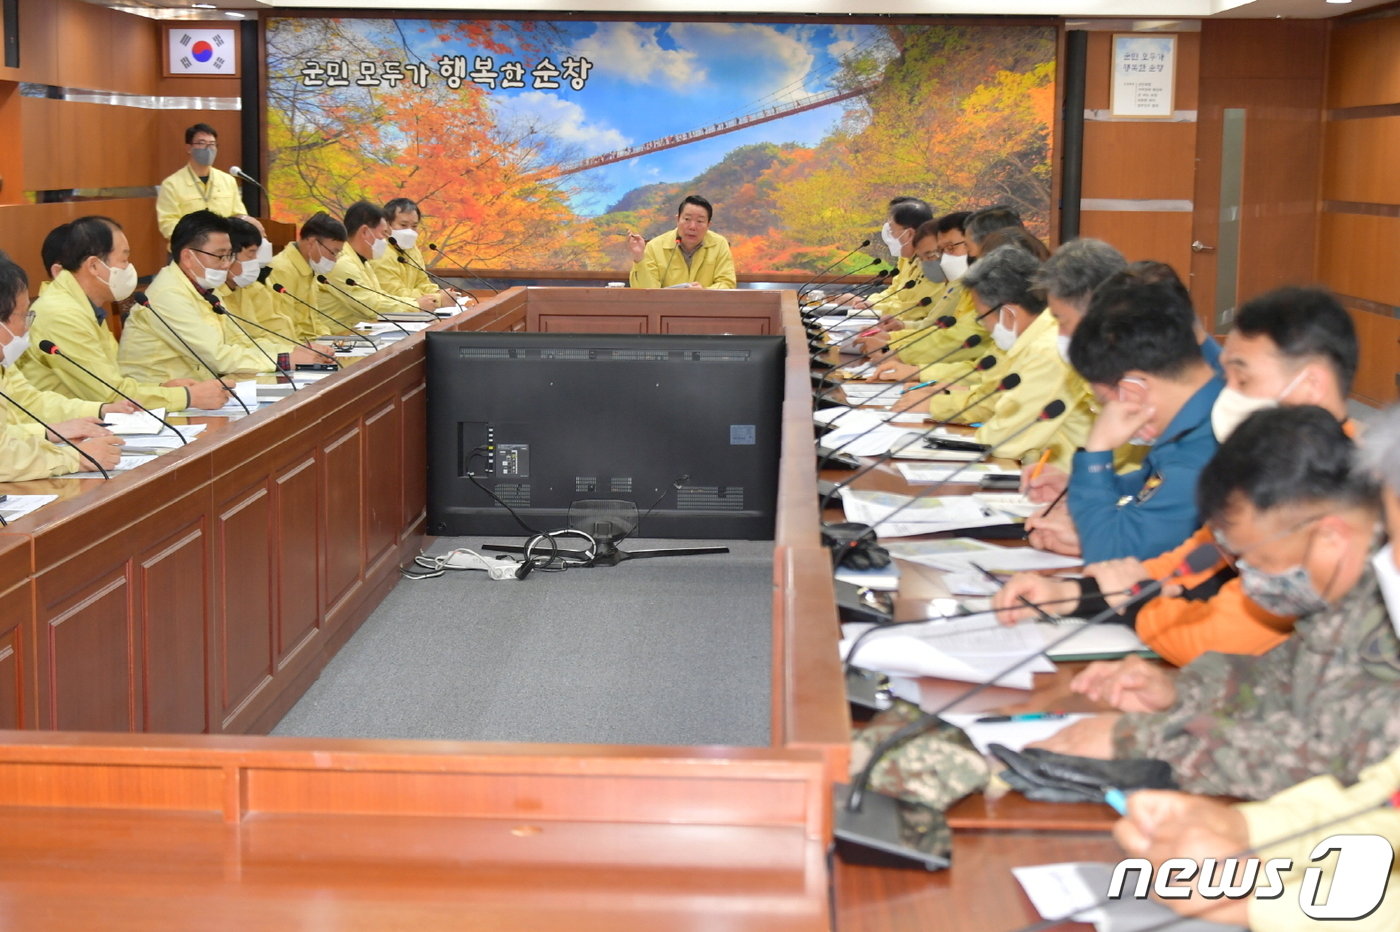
273, 455, 322, 670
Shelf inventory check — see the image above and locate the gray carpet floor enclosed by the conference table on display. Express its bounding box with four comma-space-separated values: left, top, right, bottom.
272, 537, 773, 746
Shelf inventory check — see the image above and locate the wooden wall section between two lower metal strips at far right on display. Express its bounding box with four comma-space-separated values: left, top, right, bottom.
1317, 211, 1400, 306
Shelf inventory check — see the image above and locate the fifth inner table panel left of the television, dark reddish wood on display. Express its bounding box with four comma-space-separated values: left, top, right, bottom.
214, 476, 276, 732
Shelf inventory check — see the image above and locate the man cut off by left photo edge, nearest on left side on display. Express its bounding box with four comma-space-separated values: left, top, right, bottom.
0, 252, 122, 481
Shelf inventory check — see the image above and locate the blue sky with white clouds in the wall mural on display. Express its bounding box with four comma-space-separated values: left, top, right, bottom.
407, 22, 890, 214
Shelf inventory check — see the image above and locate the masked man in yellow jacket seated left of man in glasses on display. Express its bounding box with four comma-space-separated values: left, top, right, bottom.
20, 217, 228, 411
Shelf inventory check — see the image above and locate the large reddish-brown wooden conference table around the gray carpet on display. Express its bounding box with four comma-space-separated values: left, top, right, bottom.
0, 288, 1112, 929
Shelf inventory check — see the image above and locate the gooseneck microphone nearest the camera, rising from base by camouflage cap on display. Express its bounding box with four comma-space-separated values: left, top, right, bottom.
836, 544, 1219, 868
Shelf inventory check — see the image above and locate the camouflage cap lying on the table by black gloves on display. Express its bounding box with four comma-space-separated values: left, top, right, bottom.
851, 700, 990, 812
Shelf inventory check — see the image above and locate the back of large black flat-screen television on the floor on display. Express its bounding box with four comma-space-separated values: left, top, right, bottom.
427, 332, 785, 540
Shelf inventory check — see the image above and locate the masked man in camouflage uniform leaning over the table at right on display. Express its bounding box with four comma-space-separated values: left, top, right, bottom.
1043, 404, 1400, 799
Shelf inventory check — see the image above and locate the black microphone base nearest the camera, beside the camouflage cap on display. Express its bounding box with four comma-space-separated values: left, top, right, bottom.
832, 784, 952, 870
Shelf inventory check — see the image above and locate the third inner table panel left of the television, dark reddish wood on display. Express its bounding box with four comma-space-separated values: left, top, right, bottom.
319, 418, 364, 630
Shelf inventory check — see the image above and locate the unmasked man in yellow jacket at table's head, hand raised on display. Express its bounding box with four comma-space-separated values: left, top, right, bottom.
627, 195, 738, 288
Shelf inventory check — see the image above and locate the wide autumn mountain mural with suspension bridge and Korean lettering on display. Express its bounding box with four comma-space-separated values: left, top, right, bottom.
266, 17, 1056, 273
